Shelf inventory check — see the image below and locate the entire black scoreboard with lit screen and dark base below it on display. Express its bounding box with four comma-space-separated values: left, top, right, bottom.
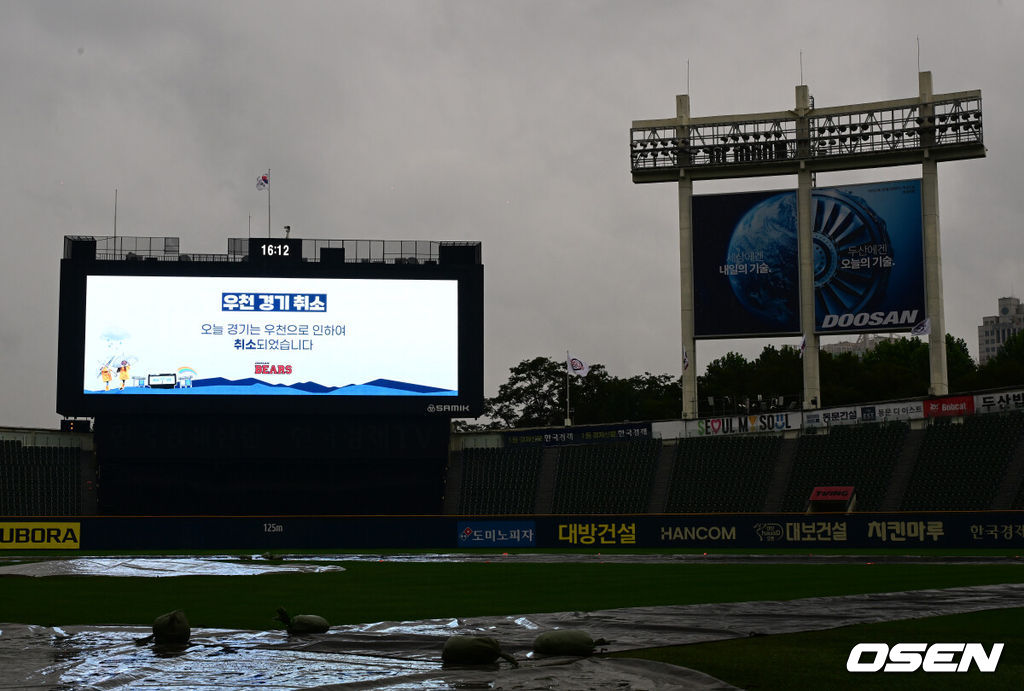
57, 235, 483, 515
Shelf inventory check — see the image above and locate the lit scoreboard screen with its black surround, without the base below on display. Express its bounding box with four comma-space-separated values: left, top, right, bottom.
57, 260, 482, 417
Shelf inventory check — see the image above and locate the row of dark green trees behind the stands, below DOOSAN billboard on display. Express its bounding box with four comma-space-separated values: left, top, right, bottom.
471, 332, 999, 429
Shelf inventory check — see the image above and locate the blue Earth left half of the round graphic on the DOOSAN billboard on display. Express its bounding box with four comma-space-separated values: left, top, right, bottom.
726, 192, 800, 331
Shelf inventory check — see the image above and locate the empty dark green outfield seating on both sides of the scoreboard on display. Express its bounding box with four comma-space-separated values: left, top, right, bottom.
0, 413, 1024, 517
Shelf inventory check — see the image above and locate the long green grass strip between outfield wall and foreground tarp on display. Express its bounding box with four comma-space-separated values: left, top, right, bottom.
0, 558, 1024, 630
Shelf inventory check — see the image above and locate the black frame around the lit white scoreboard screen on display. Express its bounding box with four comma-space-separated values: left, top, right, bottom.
56, 251, 483, 419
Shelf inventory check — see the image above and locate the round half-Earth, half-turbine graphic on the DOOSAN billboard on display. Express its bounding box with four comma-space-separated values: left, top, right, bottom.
727, 188, 895, 331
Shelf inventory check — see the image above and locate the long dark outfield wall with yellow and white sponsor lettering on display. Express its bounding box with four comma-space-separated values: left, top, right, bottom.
6, 512, 1024, 555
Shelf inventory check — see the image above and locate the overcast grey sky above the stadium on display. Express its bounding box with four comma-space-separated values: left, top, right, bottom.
0, 0, 1024, 427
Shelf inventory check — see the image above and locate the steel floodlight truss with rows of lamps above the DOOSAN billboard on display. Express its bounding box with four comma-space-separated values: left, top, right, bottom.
630, 91, 985, 182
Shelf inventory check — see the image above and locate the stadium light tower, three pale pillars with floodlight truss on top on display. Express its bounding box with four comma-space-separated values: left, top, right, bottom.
630, 72, 985, 419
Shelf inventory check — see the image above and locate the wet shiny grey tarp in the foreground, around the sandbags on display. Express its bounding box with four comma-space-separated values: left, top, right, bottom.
0, 555, 1024, 691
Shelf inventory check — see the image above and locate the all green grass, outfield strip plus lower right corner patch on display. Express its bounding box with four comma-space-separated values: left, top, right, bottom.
0, 553, 1024, 690
